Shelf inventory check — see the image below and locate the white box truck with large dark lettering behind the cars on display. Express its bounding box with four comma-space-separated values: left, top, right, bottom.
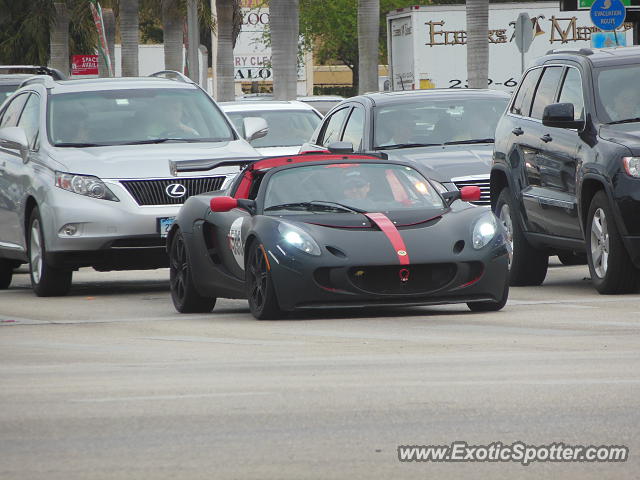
387, 2, 633, 91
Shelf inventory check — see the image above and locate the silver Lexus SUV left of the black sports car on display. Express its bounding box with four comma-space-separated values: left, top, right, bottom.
0, 75, 267, 296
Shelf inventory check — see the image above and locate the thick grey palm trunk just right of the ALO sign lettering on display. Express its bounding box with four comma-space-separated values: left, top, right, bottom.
269, 0, 300, 100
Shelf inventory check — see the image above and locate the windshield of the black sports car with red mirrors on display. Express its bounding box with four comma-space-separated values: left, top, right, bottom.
264, 163, 444, 214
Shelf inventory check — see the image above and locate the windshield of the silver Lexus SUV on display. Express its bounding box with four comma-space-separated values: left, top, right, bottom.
47, 88, 233, 146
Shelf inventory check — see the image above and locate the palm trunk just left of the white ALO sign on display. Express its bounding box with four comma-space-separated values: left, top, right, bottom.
213, 0, 236, 102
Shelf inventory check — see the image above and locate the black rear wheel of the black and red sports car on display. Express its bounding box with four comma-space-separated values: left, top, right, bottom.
169, 230, 216, 313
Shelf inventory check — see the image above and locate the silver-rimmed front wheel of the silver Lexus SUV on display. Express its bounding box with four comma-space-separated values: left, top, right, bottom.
27, 207, 73, 297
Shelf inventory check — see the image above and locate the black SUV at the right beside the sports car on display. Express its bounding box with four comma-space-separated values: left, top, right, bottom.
491, 47, 640, 293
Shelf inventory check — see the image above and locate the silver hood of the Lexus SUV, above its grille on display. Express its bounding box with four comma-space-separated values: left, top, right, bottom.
51, 140, 261, 179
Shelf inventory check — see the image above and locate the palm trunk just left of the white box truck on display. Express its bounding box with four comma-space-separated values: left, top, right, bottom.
354, 0, 380, 94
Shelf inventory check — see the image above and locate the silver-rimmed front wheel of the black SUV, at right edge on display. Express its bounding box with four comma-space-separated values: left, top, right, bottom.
586, 191, 637, 294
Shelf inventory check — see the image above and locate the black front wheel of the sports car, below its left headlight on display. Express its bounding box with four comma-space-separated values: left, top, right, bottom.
245, 240, 283, 320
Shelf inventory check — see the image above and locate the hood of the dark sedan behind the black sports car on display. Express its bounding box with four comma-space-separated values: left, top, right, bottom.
383, 143, 493, 182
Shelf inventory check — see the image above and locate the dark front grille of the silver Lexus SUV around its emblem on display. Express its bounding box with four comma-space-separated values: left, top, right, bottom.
120, 176, 226, 205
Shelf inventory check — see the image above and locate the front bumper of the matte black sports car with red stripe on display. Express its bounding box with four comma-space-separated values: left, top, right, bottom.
268, 243, 508, 310
